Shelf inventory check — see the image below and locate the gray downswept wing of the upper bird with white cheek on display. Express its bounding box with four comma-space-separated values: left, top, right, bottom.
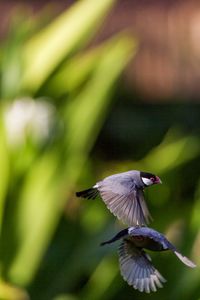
98, 182, 151, 226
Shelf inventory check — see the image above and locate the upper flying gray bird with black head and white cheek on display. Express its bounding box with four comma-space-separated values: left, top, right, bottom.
76, 170, 161, 226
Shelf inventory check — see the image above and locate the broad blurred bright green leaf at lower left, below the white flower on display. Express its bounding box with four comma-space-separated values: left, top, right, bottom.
3, 155, 60, 285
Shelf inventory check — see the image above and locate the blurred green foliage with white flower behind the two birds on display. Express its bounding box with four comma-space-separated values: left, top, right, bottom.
0, 0, 200, 300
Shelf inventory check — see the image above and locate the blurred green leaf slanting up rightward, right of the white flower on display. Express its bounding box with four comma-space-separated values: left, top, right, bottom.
61, 36, 136, 184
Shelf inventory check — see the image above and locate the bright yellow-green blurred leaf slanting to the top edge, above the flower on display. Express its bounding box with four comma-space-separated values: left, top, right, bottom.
22, 0, 115, 92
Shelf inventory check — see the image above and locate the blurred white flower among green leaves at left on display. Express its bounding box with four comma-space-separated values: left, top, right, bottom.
4, 97, 55, 145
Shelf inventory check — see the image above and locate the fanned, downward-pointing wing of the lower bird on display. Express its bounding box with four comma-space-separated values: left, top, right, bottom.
119, 240, 166, 293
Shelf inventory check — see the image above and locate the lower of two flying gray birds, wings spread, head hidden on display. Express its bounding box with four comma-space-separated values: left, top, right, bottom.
101, 227, 196, 293
